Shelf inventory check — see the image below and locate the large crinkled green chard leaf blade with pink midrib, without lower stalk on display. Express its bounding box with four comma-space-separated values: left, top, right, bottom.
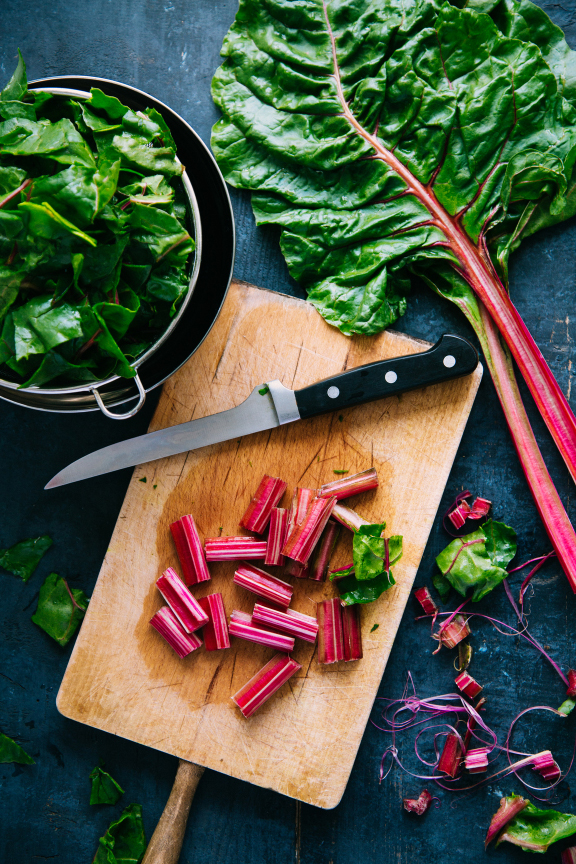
212, 0, 576, 333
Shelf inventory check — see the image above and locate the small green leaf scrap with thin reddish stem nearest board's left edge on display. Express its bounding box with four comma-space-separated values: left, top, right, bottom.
32, 573, 88, 647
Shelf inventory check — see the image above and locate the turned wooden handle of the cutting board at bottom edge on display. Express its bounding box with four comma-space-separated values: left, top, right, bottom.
142, 759, 204, 864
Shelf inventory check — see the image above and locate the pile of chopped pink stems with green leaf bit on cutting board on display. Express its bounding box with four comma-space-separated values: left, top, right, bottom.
150, 468, 394, 717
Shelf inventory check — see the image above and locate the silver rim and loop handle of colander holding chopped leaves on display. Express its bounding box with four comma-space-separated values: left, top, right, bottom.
0, 84, 202, 398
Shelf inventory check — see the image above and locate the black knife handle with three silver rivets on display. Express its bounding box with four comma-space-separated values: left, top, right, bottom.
295, 333, 478, 419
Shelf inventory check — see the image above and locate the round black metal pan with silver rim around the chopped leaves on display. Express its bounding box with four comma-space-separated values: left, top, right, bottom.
0, 77, 235, 420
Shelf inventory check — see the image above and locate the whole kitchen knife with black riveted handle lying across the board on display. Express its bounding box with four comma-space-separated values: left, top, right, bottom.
45, 334, 478, 489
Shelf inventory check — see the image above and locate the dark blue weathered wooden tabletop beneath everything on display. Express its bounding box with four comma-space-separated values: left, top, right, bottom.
0, 0, 576, 864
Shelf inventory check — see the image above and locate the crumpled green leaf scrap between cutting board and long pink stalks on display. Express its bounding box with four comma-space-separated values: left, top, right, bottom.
434, 519, 517, 600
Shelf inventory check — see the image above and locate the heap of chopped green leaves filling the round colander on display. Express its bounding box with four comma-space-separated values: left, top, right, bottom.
0, 55, 194, 387
